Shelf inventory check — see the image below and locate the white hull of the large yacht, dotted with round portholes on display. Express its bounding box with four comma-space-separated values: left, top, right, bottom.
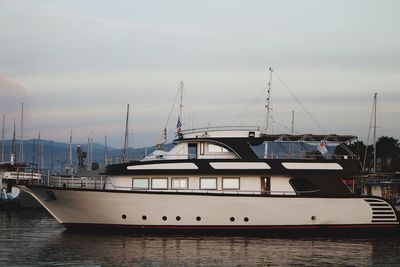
23, 187, 398, 232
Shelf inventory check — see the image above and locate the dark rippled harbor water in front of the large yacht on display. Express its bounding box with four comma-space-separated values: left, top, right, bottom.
0, 209, 400, 266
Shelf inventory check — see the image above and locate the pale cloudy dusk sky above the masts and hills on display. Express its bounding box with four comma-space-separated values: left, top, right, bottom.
0, 0, 400, 148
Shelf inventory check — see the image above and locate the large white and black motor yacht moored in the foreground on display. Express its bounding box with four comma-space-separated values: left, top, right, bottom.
22, 128, 399, 232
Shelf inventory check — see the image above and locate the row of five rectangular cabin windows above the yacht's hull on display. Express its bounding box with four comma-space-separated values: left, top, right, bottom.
132, 177, 240, 190
